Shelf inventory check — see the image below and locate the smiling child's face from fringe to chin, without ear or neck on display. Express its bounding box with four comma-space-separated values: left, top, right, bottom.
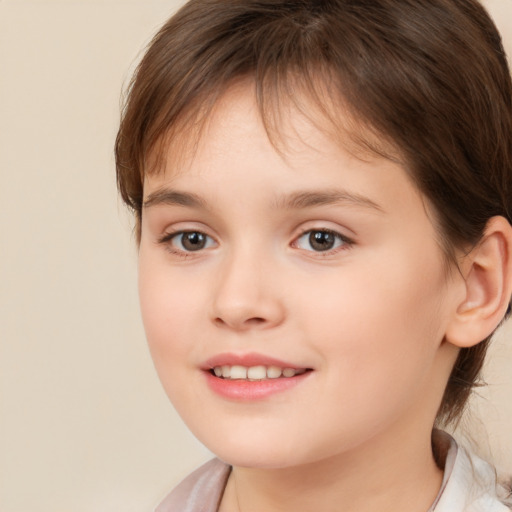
139, 83, 461, 467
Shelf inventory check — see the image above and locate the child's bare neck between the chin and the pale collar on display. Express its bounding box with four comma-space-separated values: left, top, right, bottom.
220, 426, 442, 512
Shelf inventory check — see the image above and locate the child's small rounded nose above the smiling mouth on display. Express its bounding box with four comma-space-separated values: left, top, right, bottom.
212, 249, 285, 331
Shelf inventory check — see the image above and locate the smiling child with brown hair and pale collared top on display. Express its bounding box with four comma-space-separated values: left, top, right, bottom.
116, 0, 512, 512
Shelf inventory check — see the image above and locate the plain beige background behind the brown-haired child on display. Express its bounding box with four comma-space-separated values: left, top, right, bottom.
0, 0, 512, 512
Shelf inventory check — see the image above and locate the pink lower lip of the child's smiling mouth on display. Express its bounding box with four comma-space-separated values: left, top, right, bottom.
205, 371, 312, 401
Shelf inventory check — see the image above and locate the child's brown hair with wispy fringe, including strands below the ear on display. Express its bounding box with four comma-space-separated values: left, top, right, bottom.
115, 0, 512, 423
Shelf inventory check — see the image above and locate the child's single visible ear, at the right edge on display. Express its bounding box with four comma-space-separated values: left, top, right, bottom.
445, 217, 512, 348
